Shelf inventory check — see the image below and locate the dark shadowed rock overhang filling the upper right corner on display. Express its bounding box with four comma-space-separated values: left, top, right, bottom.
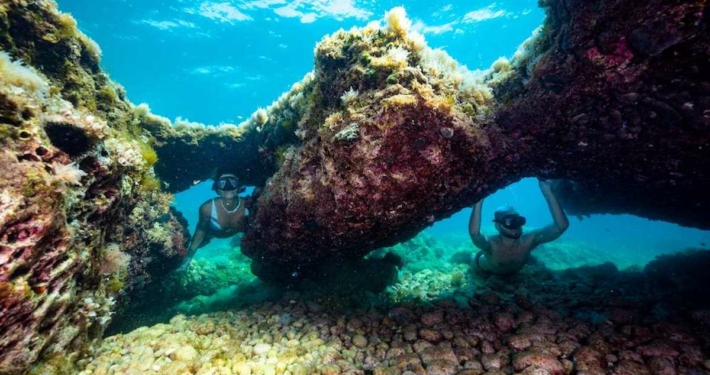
496, 1, 710, 229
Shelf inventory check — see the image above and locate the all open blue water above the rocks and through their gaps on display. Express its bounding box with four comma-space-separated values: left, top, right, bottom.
58, 0, 710, 266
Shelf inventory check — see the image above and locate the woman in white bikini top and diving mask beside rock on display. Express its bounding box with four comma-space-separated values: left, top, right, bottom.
177, 170, 250, 271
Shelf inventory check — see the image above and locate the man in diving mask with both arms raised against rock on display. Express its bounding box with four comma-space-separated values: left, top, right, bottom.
468, 180, 569, 275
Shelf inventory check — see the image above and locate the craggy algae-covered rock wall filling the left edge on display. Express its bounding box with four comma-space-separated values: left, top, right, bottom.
0, 1, 188, 374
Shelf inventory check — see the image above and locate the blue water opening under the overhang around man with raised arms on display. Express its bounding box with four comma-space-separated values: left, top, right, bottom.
425, 178, 710, 268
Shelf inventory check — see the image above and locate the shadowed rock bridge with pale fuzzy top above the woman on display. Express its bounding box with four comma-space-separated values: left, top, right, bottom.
140, 74, 313, 192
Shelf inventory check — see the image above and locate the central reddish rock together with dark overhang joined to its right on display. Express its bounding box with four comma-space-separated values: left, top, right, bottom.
242, 1, 710, 276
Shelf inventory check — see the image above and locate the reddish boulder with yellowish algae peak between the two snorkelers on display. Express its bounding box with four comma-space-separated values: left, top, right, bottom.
242, 8, 504, 274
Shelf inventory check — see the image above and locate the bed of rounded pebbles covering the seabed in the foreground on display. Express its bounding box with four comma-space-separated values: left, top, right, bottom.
80, 292, 710, 375
